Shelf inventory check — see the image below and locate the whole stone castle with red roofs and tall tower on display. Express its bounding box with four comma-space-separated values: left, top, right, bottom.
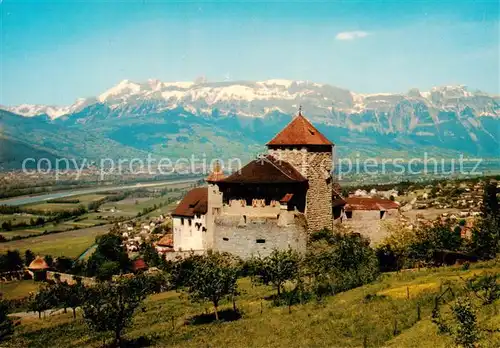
172, 111, 398, 258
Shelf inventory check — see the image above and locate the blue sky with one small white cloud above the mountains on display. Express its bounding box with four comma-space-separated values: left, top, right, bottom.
0, 0, 500, 105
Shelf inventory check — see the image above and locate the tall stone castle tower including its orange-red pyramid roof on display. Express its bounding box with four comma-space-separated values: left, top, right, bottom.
267, 110, 334, 233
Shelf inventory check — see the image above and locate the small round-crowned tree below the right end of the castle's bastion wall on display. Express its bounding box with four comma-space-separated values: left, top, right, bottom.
251, 249, 300, 298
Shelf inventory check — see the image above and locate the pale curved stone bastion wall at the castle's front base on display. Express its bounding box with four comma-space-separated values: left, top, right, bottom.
214, 211, 307, 259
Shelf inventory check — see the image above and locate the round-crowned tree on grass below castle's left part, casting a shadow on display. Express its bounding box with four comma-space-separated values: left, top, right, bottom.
187, 252, 238, 320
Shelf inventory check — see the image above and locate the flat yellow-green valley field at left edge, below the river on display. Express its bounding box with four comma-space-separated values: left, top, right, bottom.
0, 225, 109, 257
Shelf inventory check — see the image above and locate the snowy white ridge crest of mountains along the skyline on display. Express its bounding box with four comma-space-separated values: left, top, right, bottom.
0, 79, 500, 119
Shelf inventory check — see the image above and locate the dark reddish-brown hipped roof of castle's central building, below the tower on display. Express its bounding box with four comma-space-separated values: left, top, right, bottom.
221, 155, 307, 184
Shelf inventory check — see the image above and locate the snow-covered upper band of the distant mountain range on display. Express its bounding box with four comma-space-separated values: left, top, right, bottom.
3, 79, 500, 124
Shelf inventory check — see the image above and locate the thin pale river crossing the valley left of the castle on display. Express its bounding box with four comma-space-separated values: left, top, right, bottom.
0, 178, 200, 205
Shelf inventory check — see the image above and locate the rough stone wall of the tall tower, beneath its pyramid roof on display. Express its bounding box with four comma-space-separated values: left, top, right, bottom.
269, 148, 333, 233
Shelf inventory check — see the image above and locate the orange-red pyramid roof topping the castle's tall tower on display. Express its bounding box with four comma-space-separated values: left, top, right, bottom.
267, 113, 333, 146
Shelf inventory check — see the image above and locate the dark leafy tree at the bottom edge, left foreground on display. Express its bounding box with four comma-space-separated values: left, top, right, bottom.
82, 276, 147, 346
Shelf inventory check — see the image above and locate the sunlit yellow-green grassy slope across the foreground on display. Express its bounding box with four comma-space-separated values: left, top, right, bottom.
6, 261, 500, 348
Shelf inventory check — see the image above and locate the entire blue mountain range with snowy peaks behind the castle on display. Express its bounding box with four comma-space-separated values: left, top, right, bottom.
0, 80, 500, 168
